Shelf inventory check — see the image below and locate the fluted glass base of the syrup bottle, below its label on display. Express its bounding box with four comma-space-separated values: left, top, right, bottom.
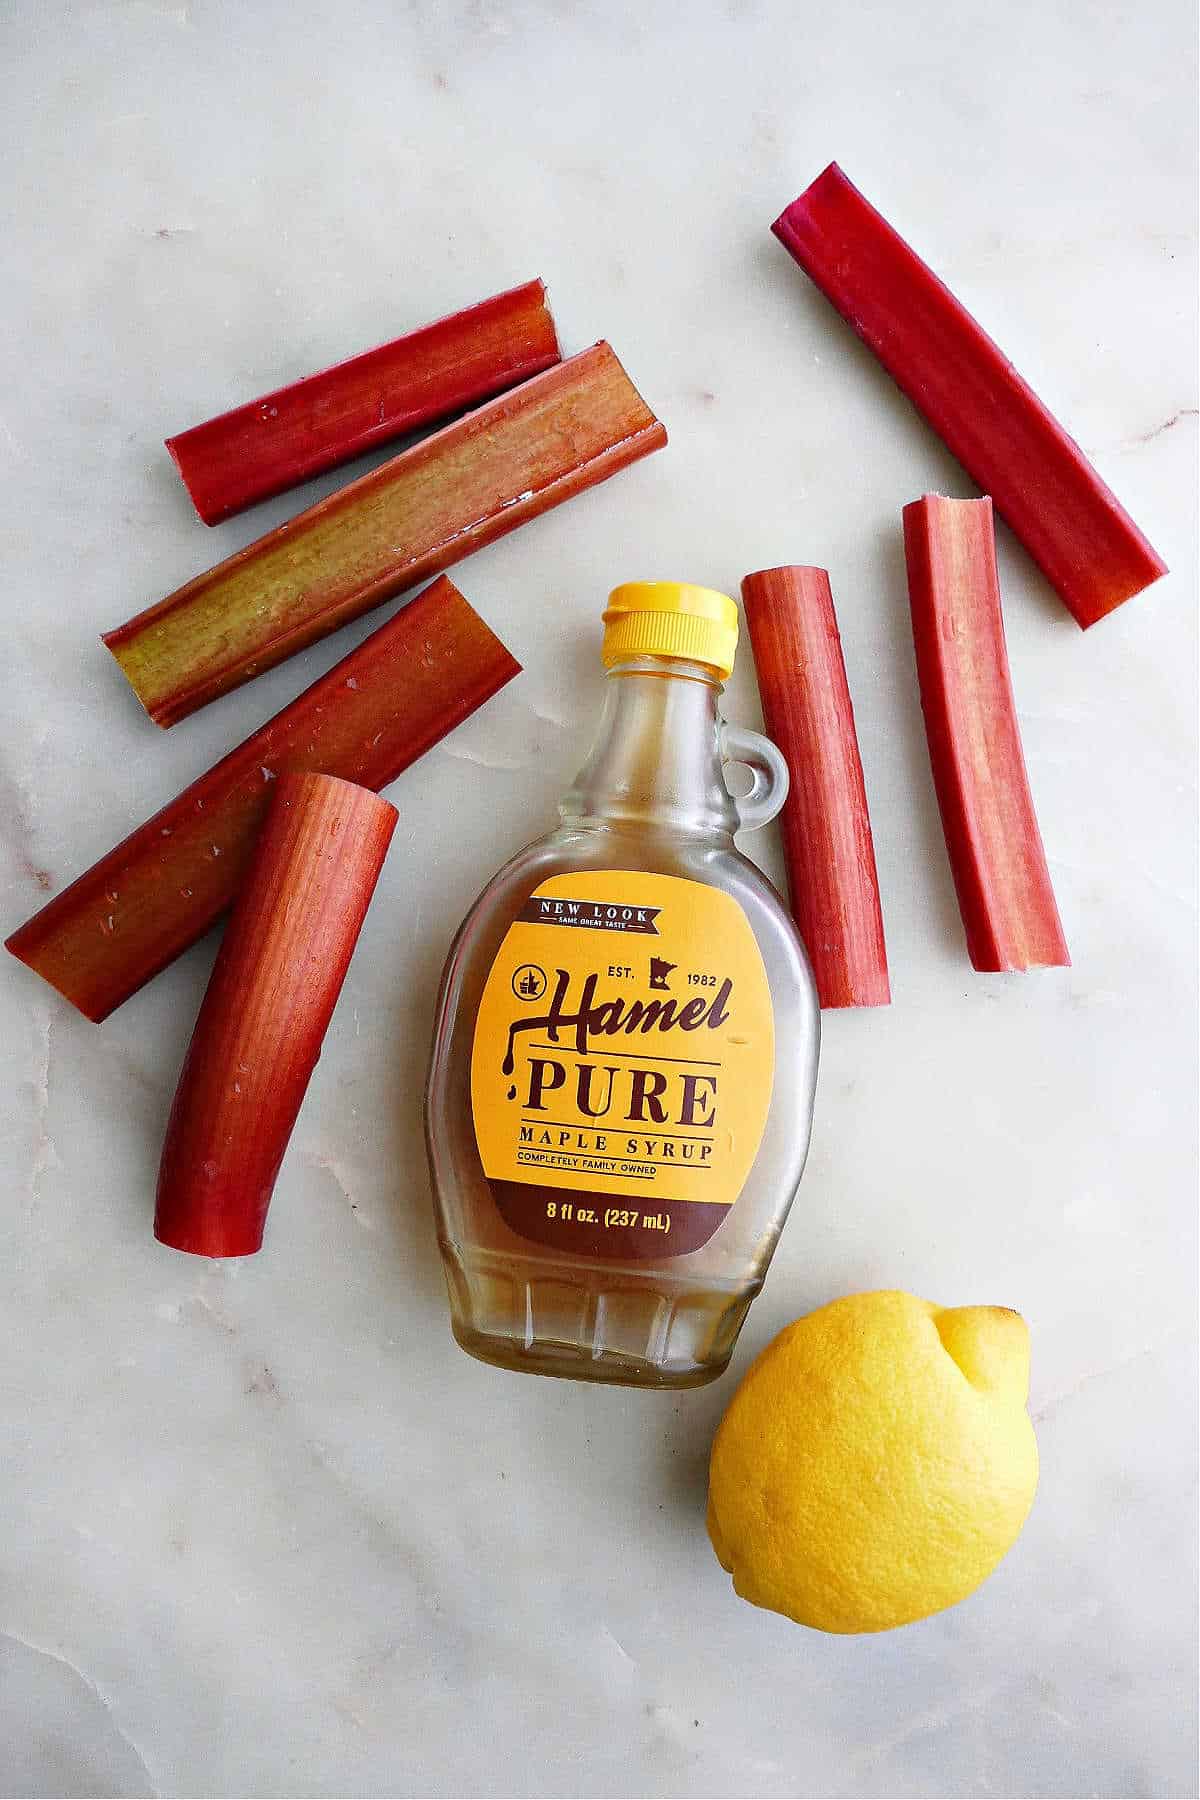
443, 1244, 759, 1388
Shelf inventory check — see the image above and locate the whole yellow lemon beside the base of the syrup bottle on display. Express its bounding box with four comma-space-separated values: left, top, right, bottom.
709, 1291, 1038, 1631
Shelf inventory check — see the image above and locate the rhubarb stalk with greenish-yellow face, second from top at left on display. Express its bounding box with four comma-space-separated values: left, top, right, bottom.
104, 344, 666, 725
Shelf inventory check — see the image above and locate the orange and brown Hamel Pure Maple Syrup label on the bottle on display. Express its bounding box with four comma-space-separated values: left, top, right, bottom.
471, 869, 775, 1260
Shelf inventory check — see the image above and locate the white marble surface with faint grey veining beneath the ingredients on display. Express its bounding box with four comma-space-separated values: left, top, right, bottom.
0, 0, 1196, 1796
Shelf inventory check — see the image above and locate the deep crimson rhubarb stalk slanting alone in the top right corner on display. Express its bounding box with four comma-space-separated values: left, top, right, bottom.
772, 162, 1166, 626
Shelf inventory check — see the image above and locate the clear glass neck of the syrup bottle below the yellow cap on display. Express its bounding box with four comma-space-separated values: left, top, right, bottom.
560, 657, 738, 837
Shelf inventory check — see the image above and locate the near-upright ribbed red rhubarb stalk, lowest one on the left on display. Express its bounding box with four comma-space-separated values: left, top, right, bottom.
155, 774, 398, 1256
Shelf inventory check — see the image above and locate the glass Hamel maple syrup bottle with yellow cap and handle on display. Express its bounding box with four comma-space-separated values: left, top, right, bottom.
425, 581, 820, 1388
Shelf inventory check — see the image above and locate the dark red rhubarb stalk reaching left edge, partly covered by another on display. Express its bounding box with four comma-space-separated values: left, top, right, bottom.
7, 576, 520, 1022
